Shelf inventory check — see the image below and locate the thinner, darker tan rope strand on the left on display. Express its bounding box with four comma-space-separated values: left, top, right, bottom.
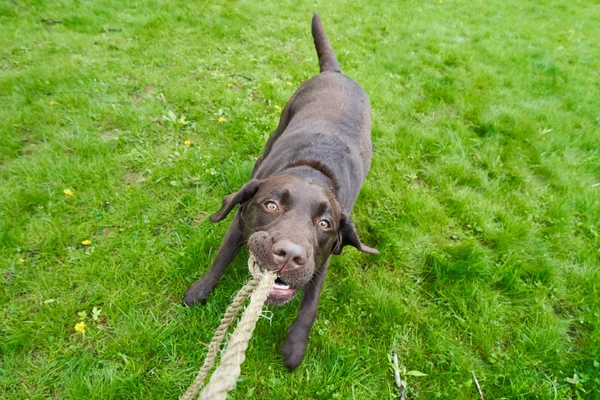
181, 278, 259, 400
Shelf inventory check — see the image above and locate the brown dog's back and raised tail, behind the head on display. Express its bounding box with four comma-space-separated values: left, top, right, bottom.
253, 14, 371, 211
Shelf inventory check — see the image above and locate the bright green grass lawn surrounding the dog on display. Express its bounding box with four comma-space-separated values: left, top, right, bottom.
0, 0, 600, 399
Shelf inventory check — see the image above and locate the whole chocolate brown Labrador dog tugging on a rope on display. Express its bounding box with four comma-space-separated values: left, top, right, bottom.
183, 14, 378, 370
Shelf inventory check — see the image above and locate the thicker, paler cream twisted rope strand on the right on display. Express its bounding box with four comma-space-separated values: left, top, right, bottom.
198, 272, 277, 400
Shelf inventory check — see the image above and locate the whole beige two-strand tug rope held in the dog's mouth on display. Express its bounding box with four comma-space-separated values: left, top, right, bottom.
181, 253, 277, 400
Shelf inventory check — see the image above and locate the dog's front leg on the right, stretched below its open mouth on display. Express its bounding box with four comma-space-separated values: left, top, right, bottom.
281, 257, 331, 371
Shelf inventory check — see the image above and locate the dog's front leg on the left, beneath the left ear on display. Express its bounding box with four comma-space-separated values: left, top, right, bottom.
183, 214, 244, 306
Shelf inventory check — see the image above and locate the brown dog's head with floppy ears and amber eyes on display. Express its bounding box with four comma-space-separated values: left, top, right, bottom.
211, 175, 377, 305
